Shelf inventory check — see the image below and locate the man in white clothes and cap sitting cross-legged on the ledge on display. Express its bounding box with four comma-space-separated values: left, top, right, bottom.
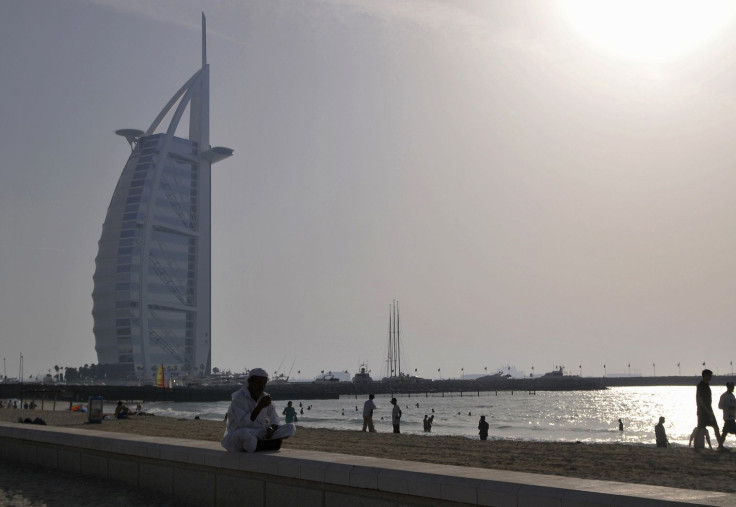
222, 368, 296, 452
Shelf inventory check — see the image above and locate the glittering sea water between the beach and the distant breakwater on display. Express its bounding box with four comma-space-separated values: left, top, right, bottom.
143, 386, 712, 445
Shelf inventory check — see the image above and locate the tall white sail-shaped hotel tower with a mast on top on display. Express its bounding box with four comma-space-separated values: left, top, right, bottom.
92, 14, 232, 379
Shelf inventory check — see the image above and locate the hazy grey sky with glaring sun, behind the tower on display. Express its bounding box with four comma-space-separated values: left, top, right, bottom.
0, 0, 736, 378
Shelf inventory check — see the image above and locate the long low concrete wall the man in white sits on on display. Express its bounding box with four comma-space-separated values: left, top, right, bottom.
0, 423, 736, 507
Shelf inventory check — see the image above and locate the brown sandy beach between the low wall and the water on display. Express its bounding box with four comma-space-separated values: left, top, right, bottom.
0, 409, 736, 492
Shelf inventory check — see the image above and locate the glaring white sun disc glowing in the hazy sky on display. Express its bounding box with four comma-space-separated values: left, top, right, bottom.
559, 0, 736, 62
